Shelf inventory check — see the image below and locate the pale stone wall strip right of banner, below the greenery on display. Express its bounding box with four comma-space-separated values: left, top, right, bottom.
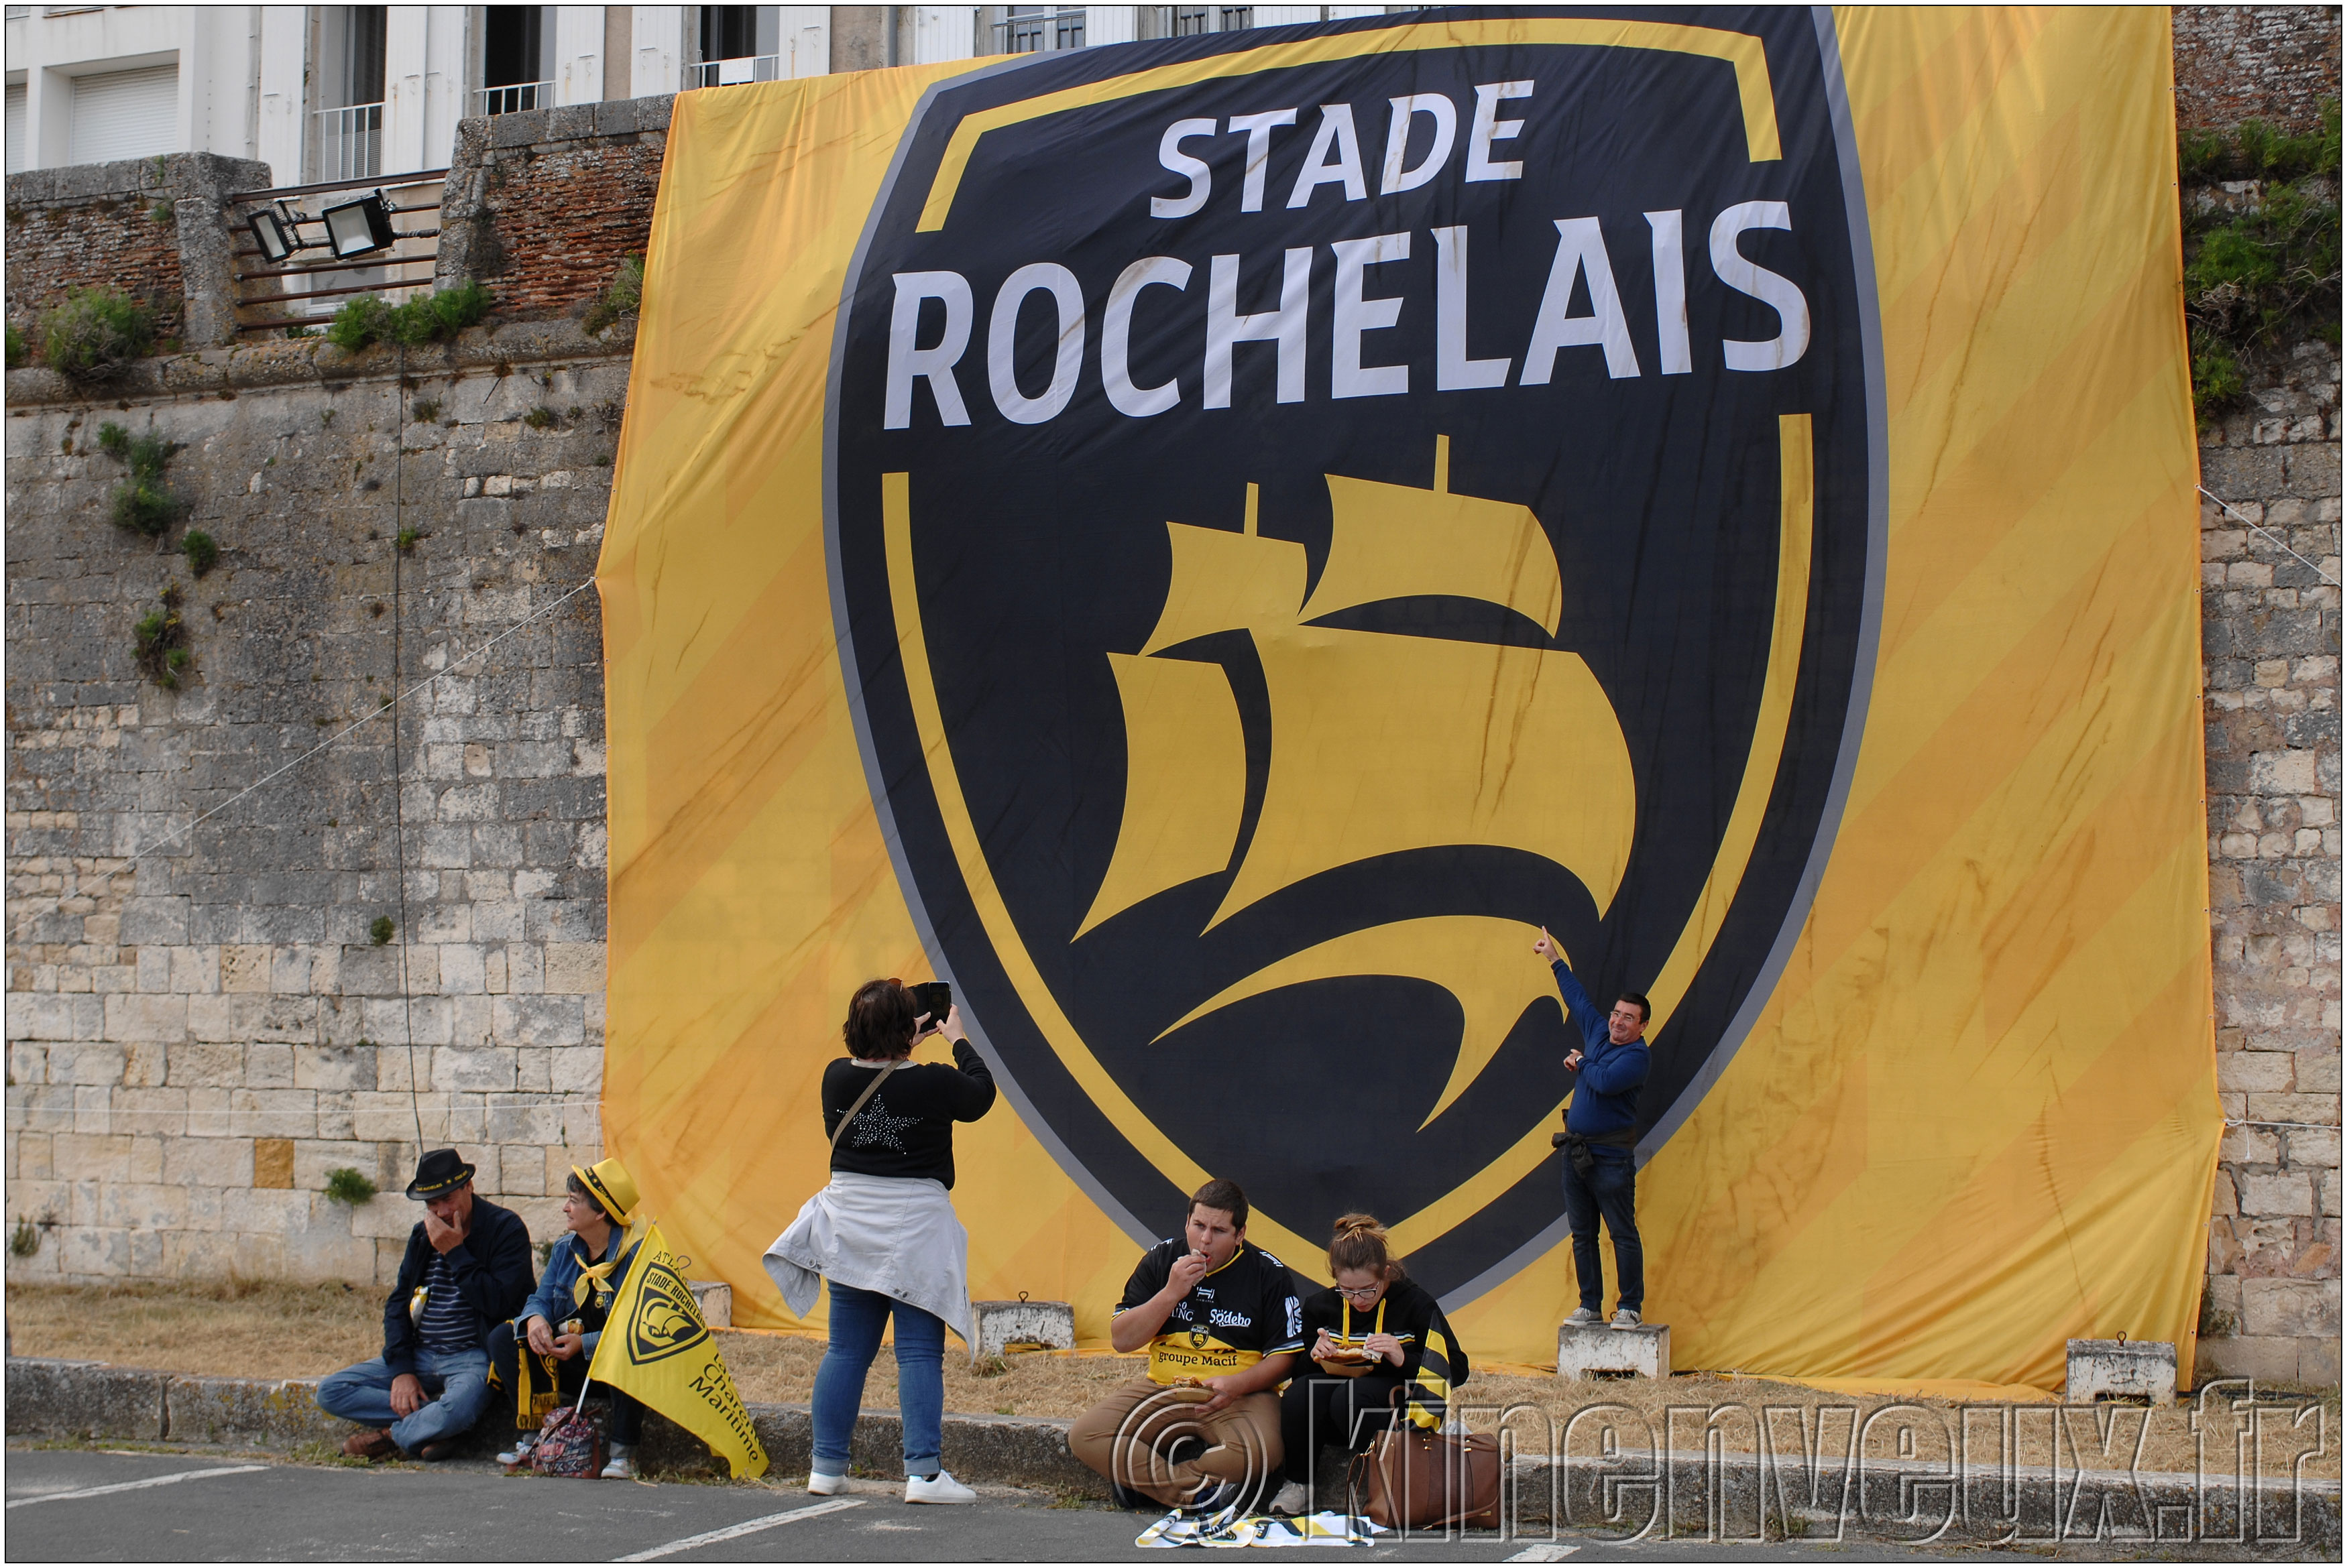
2201, 343, 2340, 1382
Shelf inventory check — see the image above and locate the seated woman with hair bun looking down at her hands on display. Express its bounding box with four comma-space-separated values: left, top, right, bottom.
1272, 1213, 1467, 1514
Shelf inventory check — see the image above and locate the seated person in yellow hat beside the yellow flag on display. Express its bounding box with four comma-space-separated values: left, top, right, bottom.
488, 1160, 643, 1481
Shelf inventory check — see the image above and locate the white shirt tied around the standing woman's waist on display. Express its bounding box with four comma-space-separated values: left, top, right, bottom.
765, 1171, 976, 1354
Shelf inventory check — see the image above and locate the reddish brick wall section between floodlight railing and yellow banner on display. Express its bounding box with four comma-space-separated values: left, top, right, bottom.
435, 99, 674, 319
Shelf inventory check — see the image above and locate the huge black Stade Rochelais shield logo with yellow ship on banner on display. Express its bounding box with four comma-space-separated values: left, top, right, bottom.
829, 7, 1880, 1298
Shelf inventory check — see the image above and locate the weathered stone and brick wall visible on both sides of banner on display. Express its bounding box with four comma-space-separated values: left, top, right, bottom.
7, 18, 2340, 1380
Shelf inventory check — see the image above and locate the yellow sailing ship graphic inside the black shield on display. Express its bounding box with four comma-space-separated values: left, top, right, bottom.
1075, 436, 1636, 1122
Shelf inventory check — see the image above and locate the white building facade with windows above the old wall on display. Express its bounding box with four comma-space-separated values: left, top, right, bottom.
5, 5, 1411, 188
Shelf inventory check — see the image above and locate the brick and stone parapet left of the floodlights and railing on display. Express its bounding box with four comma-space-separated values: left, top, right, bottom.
7, 153, 270, 347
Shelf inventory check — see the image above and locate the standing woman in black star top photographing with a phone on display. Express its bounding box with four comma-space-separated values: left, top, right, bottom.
765, 979, 995, 1502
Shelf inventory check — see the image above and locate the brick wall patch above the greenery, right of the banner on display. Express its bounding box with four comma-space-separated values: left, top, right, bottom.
2173, 5, 2340, 131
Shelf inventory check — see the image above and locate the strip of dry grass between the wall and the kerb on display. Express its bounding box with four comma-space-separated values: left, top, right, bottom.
7, 1279, 2340, 1479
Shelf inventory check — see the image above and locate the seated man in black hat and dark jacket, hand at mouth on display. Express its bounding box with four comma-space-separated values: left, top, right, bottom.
317, 1148, 530, 1460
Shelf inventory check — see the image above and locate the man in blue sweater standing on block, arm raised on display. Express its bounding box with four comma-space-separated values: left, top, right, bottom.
1533, 927, 1652, 1329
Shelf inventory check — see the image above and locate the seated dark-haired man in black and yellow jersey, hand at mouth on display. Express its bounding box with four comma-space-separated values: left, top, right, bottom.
1068, 1181, 1305, 1512
